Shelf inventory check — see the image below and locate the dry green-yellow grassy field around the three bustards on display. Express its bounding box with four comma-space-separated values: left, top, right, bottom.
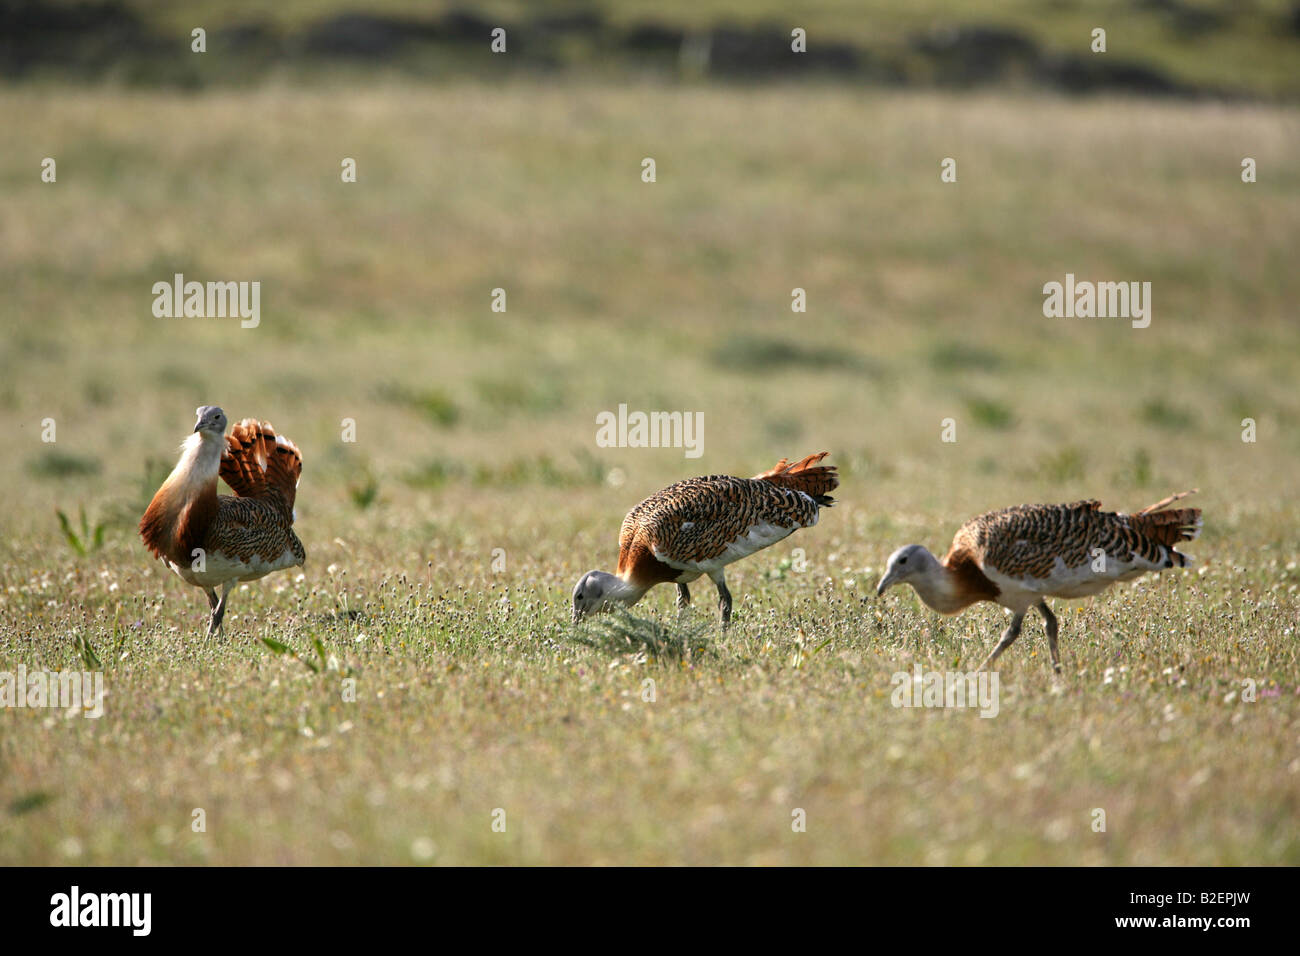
0, 83, 1300, 864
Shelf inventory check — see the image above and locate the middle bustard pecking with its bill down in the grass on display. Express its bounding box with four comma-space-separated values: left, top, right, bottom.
573, 451, 840, 626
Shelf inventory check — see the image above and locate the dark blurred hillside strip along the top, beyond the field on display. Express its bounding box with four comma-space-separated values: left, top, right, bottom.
0, 0, 1300, 100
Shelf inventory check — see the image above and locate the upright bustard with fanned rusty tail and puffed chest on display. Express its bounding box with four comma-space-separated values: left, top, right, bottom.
140, 405, 307, 637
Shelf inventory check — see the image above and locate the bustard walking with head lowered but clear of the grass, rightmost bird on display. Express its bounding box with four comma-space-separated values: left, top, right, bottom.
876, 492, 1201, 671
